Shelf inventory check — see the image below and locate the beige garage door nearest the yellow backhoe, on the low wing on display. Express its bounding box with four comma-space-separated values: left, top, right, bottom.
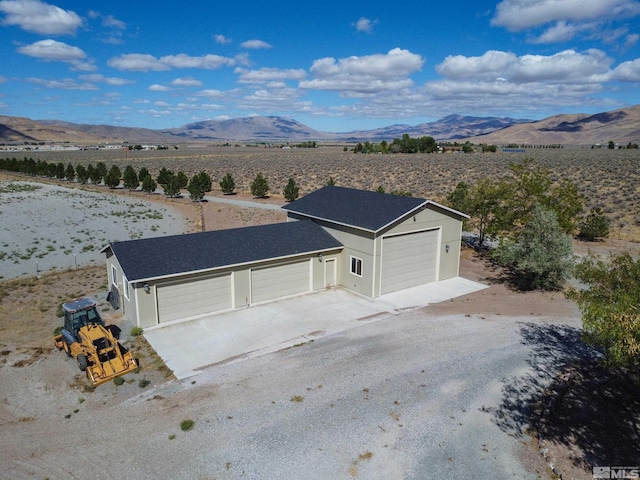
158, 274, 233, 323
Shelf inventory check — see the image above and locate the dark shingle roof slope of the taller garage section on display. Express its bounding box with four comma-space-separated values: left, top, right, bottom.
282, 186, 427, 232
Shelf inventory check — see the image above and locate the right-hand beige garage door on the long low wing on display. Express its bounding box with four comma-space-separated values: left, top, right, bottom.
251, 260, 311, 303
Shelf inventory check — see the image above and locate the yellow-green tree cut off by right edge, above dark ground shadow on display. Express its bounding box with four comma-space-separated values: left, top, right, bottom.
567, 252, 640, 377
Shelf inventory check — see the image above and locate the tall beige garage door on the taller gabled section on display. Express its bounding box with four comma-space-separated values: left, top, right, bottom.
381, 230, 440, 294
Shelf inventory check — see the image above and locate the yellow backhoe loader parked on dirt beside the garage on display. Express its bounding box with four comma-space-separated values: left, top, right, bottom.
53, 297, 138, 386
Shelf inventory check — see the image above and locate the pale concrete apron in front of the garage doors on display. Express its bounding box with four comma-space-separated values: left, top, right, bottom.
144, 277, 487, 379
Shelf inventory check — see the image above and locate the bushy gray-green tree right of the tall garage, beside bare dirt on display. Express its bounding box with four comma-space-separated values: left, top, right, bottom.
492, 204, 573, 290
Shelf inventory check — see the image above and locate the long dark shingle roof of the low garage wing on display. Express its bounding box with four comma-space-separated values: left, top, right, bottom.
105, 221, 342, 281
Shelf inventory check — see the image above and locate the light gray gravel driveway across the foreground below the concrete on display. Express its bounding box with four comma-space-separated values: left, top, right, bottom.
0, 307, 578, 480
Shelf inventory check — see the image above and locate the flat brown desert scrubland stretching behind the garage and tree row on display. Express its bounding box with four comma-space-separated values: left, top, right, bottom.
17, 146, 640, 241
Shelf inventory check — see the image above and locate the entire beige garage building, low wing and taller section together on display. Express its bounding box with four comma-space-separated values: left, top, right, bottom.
102, 186, 467, 328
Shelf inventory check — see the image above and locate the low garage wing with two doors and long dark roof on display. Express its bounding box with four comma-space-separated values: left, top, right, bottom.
103, 221, 342, 328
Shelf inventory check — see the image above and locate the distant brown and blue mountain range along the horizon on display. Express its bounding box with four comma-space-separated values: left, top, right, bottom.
0, 105, 640, 145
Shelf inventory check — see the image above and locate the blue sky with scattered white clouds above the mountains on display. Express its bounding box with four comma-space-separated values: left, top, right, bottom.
0, 0, 640, 132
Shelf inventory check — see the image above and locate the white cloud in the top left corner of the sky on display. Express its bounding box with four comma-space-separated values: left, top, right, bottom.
0, 0, 82, 35
